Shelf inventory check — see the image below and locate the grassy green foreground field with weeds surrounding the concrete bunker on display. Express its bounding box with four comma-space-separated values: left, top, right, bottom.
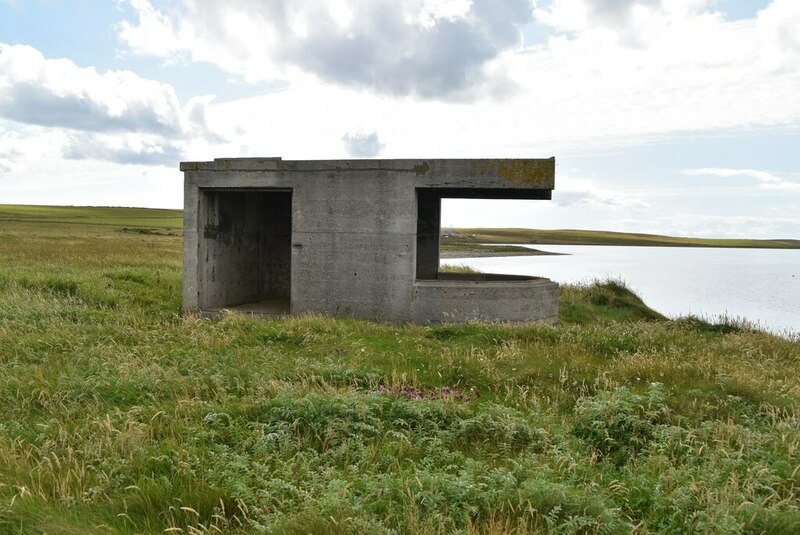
0, 204, 800, 535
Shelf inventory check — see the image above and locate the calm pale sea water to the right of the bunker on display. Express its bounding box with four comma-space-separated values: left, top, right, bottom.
443, 245, 800, 333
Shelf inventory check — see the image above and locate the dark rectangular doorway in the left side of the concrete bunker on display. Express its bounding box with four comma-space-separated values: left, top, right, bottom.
198, 189, 292, 315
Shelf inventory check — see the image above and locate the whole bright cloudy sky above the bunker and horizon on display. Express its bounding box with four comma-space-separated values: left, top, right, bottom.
0, 0, 800, 239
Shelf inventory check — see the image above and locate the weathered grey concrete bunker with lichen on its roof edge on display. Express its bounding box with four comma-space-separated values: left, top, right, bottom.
181, 158, 558, 323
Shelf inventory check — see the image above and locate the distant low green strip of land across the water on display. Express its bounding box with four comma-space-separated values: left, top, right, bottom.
449, 228, 800, 249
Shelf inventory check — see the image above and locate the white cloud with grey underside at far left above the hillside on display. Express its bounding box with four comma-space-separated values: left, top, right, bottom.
0, 43, 231, 166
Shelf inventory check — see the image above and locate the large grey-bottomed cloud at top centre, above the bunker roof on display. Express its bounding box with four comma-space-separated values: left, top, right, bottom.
118, 0, 532, 99
